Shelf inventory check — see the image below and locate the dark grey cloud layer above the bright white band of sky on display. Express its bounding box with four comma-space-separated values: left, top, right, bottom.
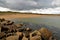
0, 0, 60, 13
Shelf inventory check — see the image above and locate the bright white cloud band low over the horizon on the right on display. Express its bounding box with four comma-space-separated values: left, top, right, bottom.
19, 7, 60, 14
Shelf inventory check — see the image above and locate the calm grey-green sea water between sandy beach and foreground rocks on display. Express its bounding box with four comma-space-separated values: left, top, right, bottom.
12, 16, 60, 39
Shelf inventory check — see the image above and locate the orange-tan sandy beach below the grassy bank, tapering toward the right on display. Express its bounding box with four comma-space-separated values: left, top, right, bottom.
0, 14, 41, 19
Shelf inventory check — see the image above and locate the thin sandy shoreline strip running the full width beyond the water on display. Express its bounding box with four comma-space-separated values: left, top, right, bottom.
0, 13, 60, 19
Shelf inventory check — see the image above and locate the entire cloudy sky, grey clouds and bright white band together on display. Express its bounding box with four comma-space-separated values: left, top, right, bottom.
0, 0, 60, 14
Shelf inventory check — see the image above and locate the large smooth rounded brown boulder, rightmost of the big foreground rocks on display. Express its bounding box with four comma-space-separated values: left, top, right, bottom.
39, 28, 52, 40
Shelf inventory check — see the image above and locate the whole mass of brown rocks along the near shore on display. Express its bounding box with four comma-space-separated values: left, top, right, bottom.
0, 18, 57, 40
